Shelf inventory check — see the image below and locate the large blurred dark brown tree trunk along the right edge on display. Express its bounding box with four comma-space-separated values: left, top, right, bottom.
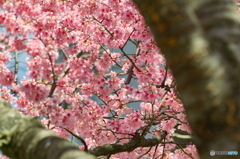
134, 0, 240, 158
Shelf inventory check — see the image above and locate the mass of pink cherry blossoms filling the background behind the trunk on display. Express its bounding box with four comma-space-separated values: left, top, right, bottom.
0, 0, 198, 159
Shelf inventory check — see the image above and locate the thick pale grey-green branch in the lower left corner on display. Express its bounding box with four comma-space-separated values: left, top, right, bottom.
0, 100, 95, 159
